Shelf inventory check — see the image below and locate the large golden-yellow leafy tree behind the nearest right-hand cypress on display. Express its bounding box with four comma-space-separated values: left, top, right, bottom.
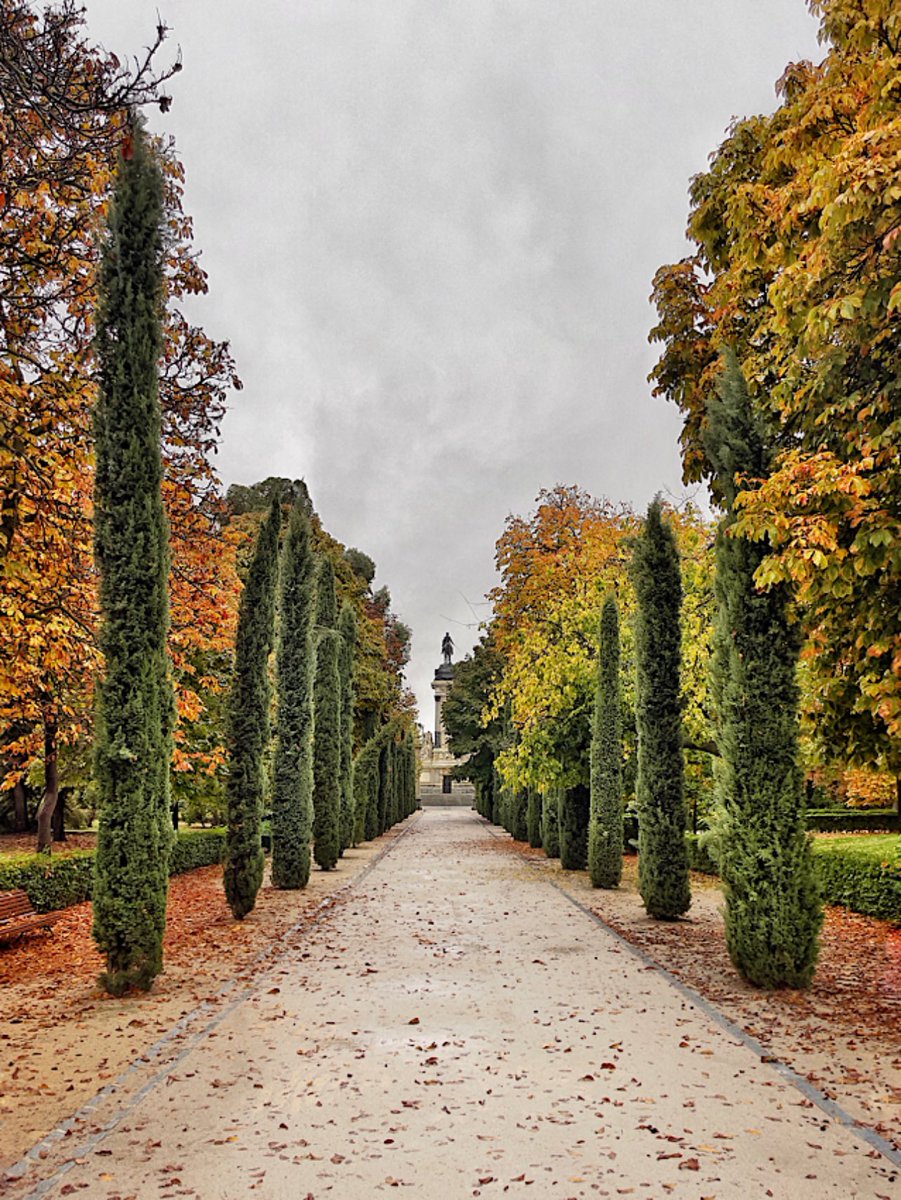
651, 7, 901, 776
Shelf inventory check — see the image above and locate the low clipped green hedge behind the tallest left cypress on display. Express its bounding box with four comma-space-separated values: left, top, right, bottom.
0, 829, 226, 912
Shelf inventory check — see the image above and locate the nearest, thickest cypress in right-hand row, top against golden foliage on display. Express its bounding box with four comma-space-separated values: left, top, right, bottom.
704, 354, 823, 988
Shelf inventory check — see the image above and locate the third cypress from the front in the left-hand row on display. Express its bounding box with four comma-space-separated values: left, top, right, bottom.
272, 496, 316, 889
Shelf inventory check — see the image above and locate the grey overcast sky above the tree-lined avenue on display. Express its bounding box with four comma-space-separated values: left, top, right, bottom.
86, 0, 821, 725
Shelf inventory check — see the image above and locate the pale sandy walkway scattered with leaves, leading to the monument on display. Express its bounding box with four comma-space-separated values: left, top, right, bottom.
5, 809, 899, 1200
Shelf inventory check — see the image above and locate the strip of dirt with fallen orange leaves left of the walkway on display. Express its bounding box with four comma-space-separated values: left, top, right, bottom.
0, 817, 415, 1168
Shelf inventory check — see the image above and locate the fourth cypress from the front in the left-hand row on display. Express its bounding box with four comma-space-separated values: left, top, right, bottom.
313, 554, 341, 871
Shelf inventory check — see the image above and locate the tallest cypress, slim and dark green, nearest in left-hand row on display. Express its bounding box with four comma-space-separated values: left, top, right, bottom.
94, 124, 174, 995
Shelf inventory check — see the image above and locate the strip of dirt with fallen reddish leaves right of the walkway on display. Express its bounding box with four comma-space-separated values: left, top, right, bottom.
520, 839, 901, 1148
